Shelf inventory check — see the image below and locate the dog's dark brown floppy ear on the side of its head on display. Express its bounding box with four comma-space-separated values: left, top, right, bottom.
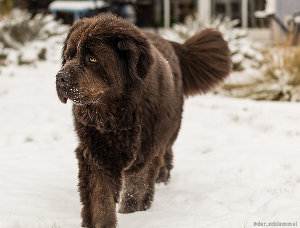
115, 37, 153, 79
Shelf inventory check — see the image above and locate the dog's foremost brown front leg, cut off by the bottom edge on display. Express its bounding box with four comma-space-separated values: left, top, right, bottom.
77, 146, 121, 228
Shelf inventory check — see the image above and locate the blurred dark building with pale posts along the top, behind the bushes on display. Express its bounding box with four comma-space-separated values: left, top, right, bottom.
11, 0, 300, 42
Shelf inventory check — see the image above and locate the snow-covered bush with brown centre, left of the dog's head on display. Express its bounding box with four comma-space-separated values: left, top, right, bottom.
0, 10, 68, 65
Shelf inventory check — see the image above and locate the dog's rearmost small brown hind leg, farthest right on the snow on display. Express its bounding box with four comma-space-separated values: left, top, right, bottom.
156, 147, 173, 184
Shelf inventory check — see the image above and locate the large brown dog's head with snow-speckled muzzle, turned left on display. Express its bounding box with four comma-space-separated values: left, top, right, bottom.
56, 14, 152, 105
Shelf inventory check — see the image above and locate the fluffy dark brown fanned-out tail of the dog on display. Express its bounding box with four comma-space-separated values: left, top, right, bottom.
171, 29, 231, 96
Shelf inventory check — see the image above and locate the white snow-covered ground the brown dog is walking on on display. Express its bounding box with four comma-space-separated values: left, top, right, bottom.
0, 38, 300, 228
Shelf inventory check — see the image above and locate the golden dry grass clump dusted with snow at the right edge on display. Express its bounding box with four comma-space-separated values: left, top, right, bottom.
218, 46, 300, 101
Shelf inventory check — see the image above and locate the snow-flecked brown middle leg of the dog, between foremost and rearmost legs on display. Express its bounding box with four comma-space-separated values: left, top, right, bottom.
119, 157, 160, 213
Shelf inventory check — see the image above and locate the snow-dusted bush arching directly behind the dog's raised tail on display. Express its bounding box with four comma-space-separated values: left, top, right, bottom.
161, 17, 263, 71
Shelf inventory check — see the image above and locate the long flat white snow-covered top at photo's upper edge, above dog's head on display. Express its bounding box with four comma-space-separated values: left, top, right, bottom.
49, 0, 107, 12
